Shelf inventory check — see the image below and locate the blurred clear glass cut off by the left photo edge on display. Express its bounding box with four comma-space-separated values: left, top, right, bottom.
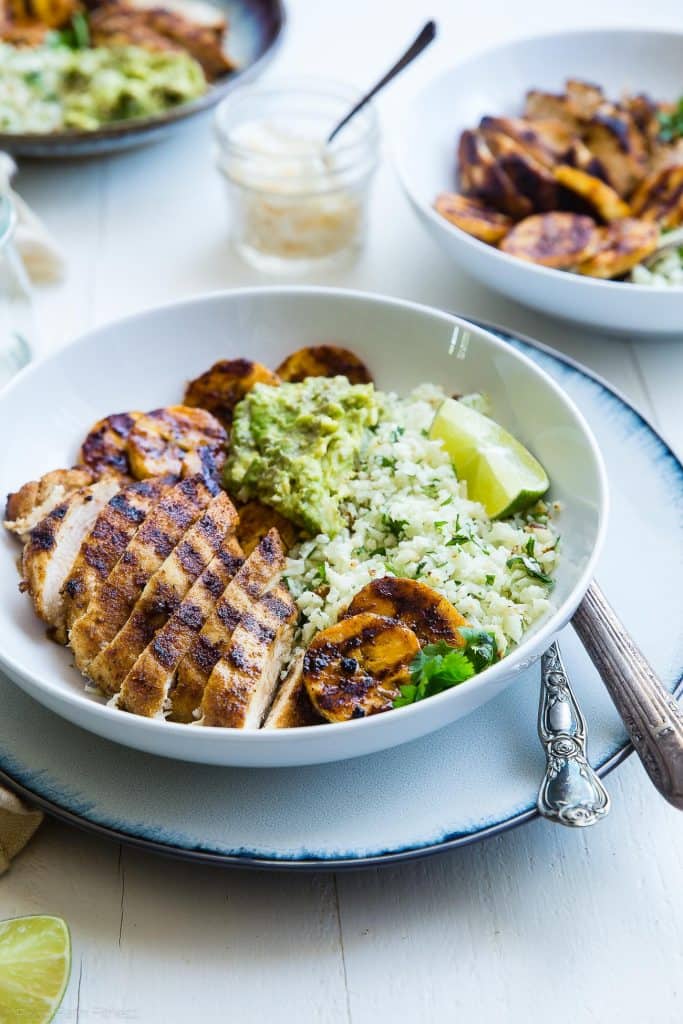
0, 194, 33, 387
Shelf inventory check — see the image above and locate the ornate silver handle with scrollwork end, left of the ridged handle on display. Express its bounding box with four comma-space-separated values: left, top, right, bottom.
538, 643, 609, 827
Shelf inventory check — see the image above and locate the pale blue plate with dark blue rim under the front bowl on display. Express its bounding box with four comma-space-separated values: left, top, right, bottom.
0, 329, 683, 868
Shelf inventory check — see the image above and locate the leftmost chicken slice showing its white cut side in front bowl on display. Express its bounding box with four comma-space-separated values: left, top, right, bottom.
22, 477, 119, 629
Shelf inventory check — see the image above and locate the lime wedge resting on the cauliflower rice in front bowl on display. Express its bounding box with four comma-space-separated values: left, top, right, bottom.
429, 398, 550, 518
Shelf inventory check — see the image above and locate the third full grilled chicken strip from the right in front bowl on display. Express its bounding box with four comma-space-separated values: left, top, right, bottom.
119, 536, 244, 718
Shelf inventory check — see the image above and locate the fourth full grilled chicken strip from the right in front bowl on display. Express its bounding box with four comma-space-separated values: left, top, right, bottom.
88, 492, 238, 695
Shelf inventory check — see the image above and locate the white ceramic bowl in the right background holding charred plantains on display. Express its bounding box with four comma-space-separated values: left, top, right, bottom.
394, 29, 683, 335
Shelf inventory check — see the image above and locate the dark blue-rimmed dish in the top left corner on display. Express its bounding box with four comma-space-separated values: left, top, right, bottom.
0, 0, 285, 160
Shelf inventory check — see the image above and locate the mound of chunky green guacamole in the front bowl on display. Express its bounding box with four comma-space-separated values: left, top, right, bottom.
225, 377, 378, 537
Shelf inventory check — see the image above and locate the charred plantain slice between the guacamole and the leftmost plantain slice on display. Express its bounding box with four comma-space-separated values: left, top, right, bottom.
127, 406, 227, 480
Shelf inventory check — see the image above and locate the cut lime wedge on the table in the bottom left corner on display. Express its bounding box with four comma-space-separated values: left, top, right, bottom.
0, 916, 71, 1024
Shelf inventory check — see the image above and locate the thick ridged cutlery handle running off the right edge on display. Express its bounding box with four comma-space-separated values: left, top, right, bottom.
571, 582, 683, 810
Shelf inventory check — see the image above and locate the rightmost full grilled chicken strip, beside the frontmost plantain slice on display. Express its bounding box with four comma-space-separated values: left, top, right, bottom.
200, 584, 297, 729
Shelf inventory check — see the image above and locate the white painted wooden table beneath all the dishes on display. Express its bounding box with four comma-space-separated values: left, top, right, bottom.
5, 0, 683, 1024
